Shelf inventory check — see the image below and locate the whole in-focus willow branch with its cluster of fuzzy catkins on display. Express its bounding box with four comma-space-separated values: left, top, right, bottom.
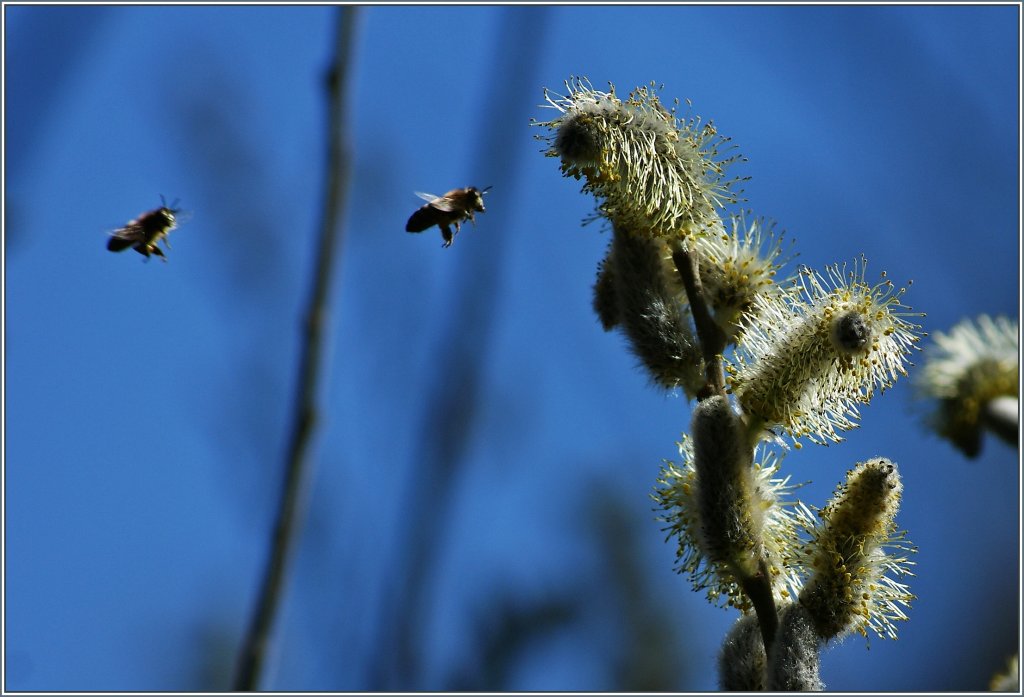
535, 78, 925, 690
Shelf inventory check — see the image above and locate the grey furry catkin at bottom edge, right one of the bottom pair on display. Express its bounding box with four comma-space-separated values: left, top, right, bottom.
768, 603, 824, 692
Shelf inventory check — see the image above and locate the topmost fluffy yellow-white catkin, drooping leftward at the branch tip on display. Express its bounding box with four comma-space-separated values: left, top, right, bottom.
537, 78, 739, 237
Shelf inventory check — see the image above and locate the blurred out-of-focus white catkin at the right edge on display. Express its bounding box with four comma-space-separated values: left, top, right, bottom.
914, 315, 1020, 458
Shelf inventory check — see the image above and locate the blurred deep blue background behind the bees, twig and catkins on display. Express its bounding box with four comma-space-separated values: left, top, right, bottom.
4, 5, 1020, 691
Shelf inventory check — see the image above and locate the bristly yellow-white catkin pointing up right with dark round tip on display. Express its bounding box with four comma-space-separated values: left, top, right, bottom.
726, 260, 922, 443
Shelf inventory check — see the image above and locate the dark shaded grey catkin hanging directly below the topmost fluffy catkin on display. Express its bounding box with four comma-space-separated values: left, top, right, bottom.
598, 227, 703, 396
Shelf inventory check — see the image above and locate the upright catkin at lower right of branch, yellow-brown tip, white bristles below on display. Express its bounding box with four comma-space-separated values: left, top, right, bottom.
795, 458, 915, 641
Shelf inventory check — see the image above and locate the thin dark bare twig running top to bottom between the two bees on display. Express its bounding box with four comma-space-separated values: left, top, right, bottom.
234, 5, 356, 691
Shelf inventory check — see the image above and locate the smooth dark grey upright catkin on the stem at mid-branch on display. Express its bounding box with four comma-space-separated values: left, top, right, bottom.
692, 395, 762, 578
